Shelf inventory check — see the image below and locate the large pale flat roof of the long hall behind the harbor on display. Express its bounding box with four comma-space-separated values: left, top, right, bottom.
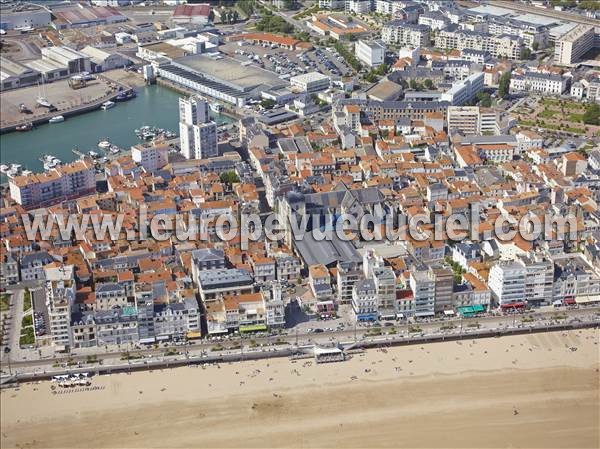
175, 55, 287, 90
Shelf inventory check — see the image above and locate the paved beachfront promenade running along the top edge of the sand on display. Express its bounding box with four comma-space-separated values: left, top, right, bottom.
3, 308, 600, 381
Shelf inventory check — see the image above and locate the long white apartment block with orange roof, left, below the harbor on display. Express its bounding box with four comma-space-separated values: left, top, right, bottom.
8, 159, 96, 209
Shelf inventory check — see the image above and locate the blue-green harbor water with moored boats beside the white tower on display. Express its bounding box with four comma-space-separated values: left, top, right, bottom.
0, 85, 233, 178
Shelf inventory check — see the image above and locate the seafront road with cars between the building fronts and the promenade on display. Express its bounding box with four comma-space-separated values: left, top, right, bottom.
3, 307, 600, 373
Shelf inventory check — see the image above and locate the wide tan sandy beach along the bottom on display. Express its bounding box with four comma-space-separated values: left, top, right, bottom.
0, 329, 600, 449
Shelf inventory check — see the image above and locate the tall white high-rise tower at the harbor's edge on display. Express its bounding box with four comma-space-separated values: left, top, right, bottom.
179, 97, 219, 159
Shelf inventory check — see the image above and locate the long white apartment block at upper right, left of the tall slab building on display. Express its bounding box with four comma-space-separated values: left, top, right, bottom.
435, 30, 523, 59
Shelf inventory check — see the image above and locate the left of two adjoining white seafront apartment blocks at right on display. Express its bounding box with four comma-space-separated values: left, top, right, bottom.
488, 262, 527, 306
